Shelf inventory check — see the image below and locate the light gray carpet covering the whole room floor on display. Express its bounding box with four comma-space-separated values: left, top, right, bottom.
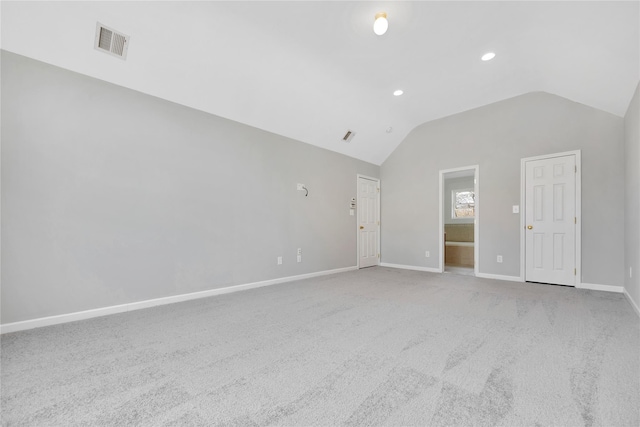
1, 267, 640, 426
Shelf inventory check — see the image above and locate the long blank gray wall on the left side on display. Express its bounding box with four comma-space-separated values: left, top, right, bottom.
1, 51, 379, 324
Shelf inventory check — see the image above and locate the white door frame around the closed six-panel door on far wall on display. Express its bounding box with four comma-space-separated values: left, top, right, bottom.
520, 150, 582, 287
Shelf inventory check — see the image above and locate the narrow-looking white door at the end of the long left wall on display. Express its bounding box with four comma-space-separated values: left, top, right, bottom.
356, 177, 380, 268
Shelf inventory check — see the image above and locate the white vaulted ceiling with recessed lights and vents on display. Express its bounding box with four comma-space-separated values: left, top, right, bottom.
0, 1, 640, 164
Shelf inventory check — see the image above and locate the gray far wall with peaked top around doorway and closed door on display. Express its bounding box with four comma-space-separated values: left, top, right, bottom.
380, 92, 624, 286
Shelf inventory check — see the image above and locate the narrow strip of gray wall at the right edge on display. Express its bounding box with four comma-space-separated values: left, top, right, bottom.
624, 85, 640, 307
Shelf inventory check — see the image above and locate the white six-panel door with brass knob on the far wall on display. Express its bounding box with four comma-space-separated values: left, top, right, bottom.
525, 155, 577, 286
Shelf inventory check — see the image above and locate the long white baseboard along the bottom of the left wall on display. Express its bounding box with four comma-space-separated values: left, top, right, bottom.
0, 266, 358, 334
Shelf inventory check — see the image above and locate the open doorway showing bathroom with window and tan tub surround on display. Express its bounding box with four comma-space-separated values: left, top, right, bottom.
440, 165, 480, 276
